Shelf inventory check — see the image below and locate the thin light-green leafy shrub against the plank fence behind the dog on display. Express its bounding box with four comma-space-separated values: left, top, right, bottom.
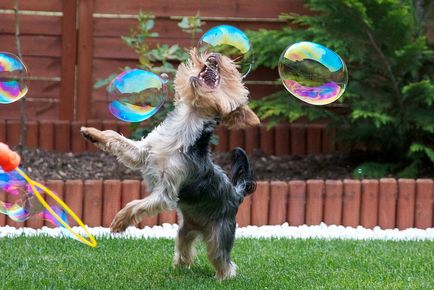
94, 12, 204, 139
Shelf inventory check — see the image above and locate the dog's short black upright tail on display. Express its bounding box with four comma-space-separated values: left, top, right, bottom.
232, 147, 256, 196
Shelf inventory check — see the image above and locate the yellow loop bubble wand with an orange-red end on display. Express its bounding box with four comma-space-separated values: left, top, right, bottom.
0, 142, 97, 248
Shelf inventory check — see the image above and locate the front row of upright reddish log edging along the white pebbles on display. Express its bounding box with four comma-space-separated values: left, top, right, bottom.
0, 178, 433, 230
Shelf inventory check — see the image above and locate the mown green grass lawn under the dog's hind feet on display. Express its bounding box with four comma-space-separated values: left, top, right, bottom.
0, 237, 434, 290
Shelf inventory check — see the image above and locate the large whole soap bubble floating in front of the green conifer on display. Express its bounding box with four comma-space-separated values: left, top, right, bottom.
278, 42, 348, 105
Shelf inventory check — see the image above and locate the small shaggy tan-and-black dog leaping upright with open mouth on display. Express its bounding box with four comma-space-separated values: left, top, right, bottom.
81, 49, 260, 280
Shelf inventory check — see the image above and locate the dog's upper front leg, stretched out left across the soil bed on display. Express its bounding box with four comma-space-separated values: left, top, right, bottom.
80, 127, 147, 169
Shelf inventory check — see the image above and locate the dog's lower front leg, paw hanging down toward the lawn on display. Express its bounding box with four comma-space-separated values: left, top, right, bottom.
110, 193, 169, 233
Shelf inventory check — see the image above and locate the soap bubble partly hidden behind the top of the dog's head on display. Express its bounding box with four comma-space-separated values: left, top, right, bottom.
199, 25, 253, 77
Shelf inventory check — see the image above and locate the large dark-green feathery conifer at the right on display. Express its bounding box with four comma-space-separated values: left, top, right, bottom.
249, 0, 434, 174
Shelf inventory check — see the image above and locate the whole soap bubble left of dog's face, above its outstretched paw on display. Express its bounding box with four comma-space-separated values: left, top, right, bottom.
107, 69, 167, 122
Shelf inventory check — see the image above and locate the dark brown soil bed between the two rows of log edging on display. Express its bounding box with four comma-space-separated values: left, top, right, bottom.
18, 149, 434, 180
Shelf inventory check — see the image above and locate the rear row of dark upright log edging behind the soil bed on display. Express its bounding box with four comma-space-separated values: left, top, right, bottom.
0, 120, 342, 156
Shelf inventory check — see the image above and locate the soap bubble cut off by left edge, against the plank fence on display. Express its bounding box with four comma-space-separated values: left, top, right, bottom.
0, 52, 29, 104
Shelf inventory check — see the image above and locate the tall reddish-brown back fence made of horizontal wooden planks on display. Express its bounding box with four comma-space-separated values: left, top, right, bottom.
0, 0, 306, 121
